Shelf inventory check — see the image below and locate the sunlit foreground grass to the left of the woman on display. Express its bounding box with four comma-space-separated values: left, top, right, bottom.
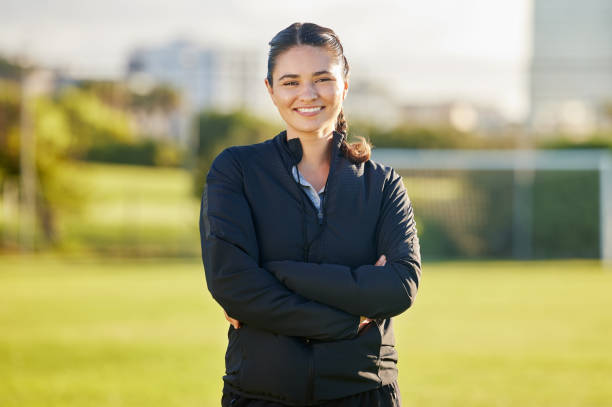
0, 258, 221, 406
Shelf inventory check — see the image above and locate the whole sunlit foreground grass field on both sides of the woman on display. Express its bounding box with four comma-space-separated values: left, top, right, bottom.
0, 256, 612, 407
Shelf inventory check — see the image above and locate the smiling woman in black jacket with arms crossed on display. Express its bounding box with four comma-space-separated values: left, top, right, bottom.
200, 23, 421, 407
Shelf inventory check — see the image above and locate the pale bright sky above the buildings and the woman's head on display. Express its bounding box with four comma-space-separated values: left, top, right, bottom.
0, 0, 531, 120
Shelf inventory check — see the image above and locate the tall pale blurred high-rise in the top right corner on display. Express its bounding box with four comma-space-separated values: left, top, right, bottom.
529, 0, 612, 134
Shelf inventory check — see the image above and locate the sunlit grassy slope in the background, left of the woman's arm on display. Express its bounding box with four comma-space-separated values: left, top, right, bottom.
0, 162, 200, 257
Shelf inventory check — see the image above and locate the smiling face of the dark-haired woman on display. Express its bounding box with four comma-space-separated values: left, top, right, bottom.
265, 45, 348, 135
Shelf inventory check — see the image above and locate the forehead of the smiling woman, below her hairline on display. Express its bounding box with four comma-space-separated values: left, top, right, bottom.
274, 45, 341, 76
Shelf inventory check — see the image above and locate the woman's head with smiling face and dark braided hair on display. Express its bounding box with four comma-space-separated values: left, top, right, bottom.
265, 23, 370, 170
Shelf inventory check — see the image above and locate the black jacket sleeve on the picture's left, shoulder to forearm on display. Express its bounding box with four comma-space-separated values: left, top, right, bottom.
200, 147, 359, 340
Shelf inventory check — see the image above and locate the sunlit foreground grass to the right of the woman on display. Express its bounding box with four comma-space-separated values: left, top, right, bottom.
396, 261, 612, 407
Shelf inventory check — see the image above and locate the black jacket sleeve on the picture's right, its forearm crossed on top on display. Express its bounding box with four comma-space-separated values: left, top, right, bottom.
263, 169, 421, 318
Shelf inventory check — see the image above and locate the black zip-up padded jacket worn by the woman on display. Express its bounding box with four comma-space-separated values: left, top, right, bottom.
200, 131, 421, 406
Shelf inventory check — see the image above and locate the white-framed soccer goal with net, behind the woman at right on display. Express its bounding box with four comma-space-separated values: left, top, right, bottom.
372, 148, 612, 262
